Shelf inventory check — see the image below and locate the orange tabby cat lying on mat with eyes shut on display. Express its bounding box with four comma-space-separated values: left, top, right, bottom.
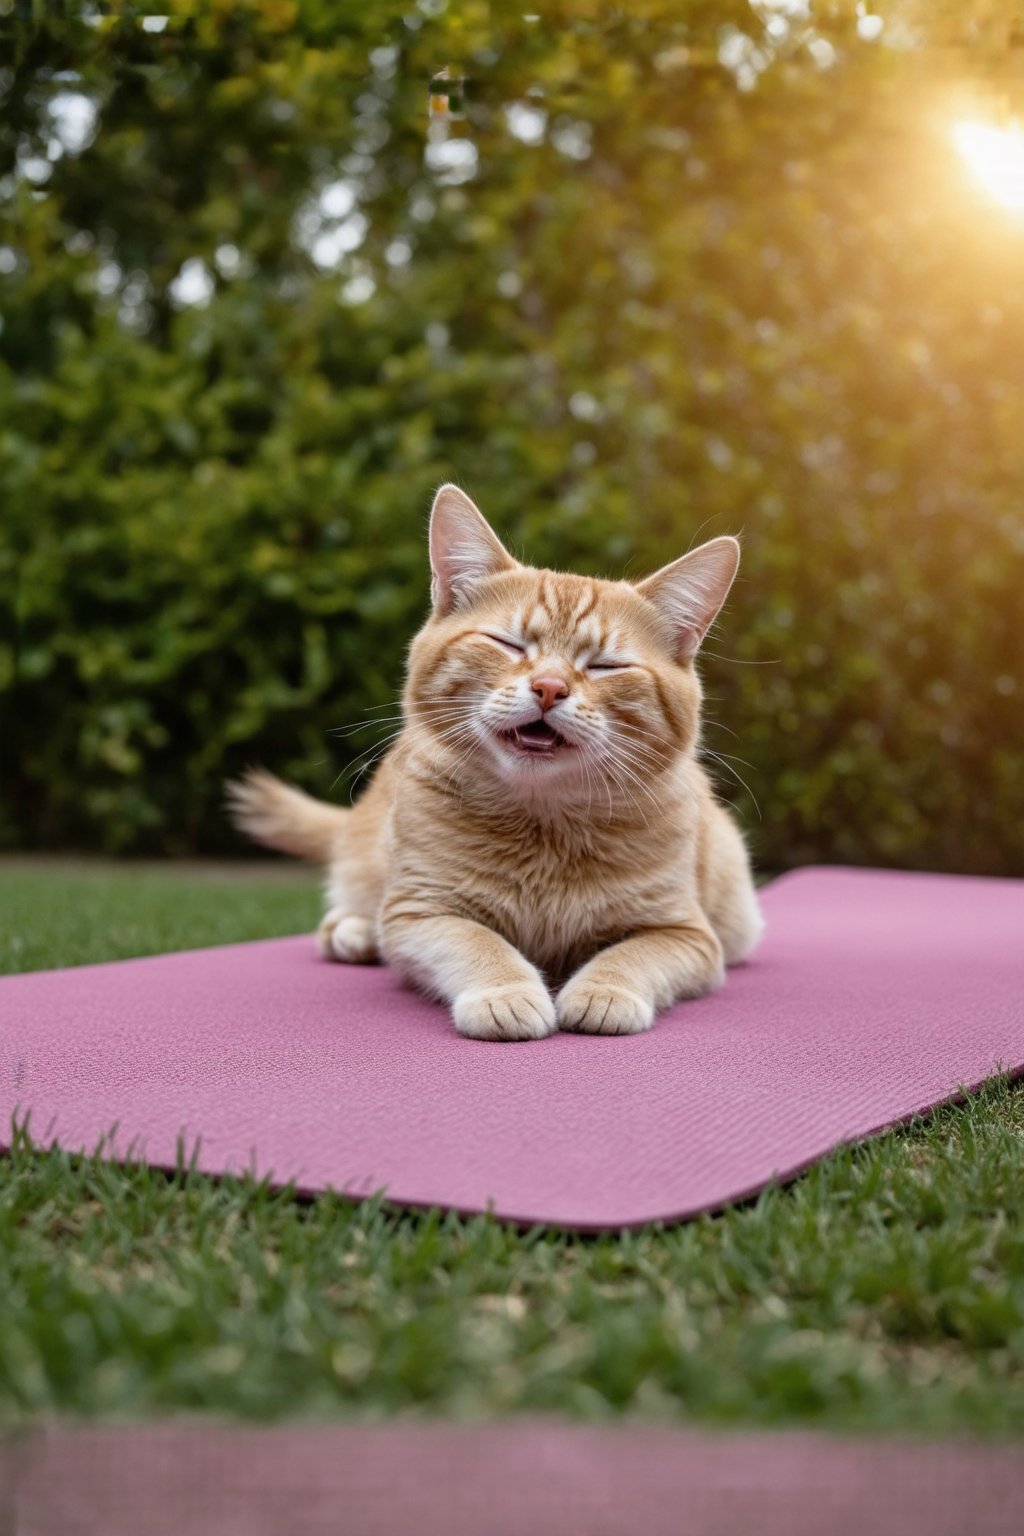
229, 485, 761, 1040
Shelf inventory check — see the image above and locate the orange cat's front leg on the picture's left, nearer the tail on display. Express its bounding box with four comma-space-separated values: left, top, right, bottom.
381, 902, 557, 1040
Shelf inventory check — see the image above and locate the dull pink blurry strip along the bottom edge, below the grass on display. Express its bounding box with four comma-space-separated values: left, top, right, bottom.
8, 1419, 1024, 1536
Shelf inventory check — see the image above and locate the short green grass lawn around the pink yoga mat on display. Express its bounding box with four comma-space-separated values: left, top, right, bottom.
0, 868, 1024, 1435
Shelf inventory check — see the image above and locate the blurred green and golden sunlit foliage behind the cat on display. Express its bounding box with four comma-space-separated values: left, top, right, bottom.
0, 0, 1024, 876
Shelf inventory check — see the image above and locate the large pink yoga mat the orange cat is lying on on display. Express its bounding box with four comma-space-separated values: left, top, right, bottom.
0, 869, 1024, 1230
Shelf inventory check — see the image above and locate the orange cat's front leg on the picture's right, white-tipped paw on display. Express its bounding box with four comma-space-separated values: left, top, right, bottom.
557, 919, 725, 1035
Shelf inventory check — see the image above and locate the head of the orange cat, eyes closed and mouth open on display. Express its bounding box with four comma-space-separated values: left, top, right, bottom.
405, 485, 740, 811
